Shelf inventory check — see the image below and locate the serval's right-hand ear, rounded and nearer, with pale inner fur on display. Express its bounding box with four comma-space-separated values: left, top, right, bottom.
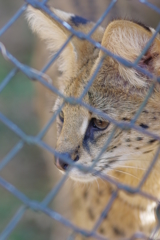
100, 20, 160, 88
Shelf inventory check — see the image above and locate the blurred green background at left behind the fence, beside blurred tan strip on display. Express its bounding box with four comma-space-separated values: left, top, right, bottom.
0, 0, 51, 240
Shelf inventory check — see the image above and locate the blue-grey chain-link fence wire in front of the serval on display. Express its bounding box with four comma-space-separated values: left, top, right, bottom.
0, 0, 160, 240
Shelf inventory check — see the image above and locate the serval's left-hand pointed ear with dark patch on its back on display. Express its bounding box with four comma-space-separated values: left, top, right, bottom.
27, 6, 104, 78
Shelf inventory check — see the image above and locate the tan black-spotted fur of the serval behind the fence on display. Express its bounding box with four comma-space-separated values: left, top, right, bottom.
28, 8, 160, 239
